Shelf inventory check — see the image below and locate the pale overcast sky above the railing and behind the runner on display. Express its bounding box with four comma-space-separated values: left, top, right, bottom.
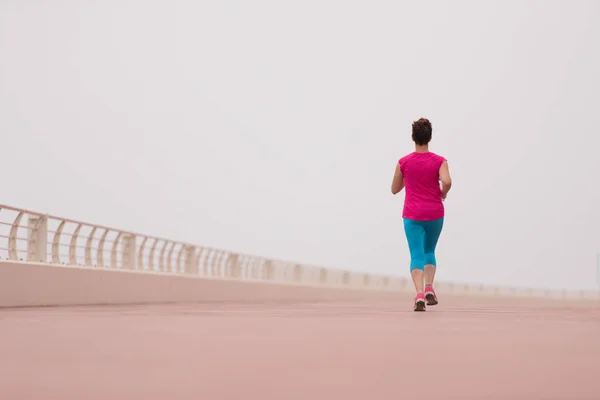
0, 0, 600, 288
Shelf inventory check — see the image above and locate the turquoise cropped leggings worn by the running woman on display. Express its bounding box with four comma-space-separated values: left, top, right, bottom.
404, 218, 444, 272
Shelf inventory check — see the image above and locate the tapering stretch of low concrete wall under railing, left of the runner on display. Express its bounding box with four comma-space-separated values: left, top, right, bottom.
0, 261, 401, 307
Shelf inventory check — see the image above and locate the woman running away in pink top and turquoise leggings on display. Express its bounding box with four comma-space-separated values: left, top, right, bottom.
392, 118, 452, 311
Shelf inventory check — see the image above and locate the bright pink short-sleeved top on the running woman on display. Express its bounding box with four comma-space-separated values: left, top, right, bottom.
398, 152, 446, 221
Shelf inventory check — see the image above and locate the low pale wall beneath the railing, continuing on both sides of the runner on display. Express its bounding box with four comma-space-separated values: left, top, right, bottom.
0, 261, 600, 308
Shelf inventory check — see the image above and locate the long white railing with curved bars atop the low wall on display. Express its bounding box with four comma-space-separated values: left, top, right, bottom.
0, 205, 600, 300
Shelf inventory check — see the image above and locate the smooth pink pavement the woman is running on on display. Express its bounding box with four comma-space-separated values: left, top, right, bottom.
0, 295, 600, 400
